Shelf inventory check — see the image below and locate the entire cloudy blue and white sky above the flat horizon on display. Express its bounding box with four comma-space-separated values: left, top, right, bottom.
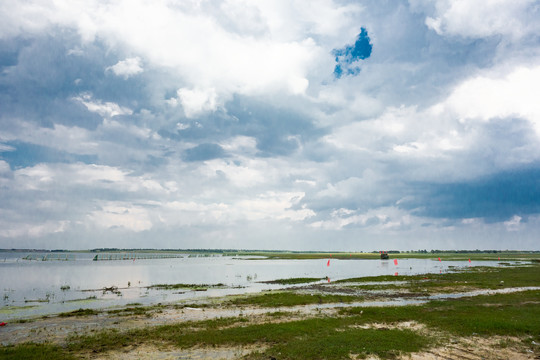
0, 0, 540, 251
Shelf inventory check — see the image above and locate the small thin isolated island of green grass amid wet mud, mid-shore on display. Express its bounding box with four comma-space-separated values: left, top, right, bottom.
226, 291, 362, 307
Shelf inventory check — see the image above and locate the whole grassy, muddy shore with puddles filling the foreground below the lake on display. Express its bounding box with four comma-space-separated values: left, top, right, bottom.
0, 252, 540, 359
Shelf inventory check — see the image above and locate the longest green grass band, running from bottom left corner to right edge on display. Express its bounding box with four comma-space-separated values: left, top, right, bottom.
5, 291, 540, 359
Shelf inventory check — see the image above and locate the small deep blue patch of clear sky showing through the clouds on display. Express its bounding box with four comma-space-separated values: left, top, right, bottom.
332, 28, 373, 79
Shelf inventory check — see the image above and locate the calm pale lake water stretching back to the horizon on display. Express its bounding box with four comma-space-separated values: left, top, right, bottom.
0, 252, 498, 320
